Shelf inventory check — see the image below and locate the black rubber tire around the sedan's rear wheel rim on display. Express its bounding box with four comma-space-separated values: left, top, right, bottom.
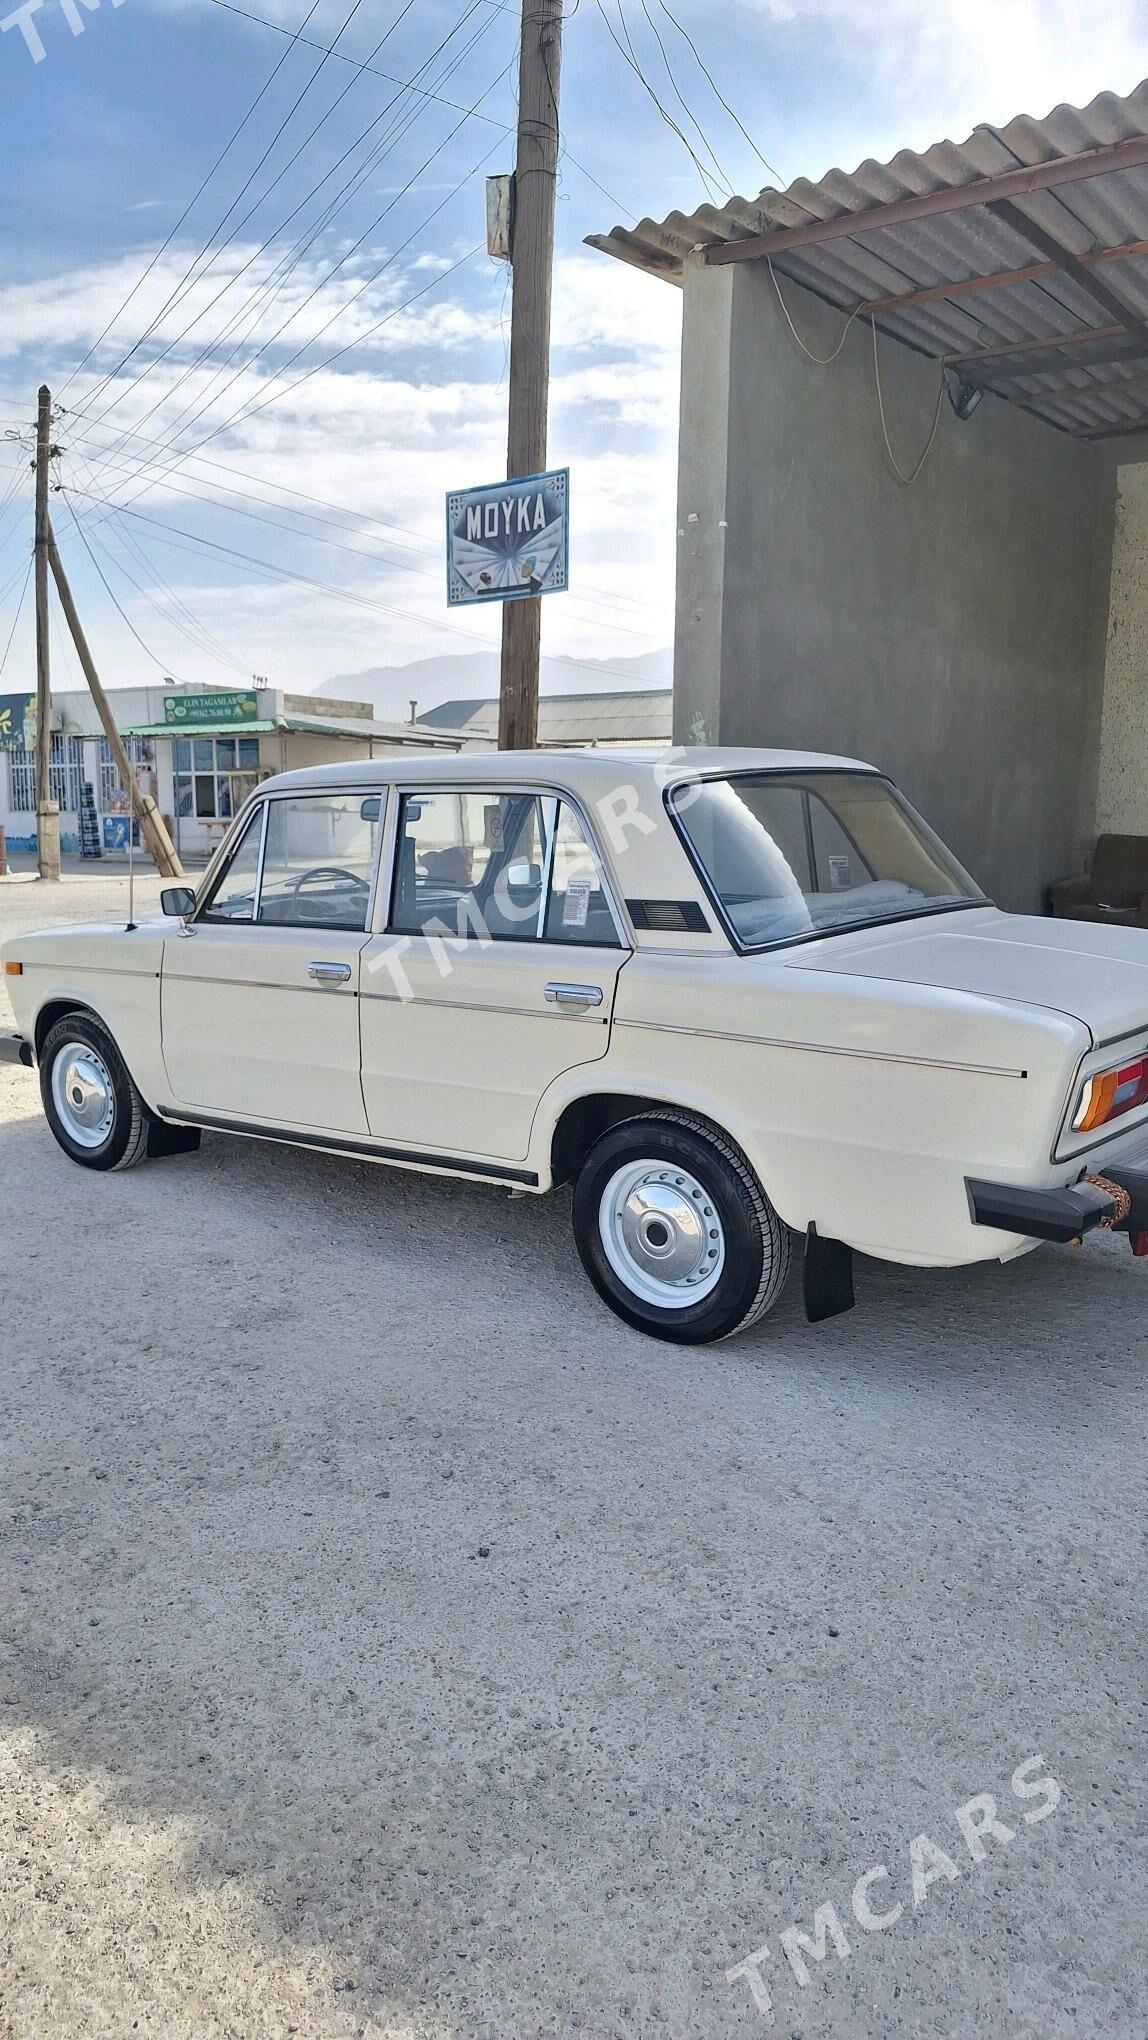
573, 1108, 789, 1346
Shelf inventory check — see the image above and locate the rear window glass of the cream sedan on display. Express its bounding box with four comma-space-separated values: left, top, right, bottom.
669, 771, 985, 949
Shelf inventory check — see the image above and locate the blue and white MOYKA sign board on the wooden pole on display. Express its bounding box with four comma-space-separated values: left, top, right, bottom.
447, 467, 571, 608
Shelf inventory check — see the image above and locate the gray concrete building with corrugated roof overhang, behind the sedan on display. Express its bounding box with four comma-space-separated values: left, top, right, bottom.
591, 86, 1148, 910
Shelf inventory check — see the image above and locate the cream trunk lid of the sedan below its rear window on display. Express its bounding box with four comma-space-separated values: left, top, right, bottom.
787, 908, 1148, 1044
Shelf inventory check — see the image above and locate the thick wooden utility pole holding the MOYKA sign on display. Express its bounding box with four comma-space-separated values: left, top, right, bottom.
498, 0, 563, 751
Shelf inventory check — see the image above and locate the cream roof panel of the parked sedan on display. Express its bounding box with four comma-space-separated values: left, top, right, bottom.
259, 745, 879, 796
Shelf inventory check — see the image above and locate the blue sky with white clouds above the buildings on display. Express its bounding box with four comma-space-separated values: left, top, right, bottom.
0, 0, 1148, 692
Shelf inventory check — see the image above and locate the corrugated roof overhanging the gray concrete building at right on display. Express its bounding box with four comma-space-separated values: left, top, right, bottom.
589, 82, 1148, 435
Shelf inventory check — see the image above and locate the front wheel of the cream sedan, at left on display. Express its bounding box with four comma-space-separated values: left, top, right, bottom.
39, 1012, 147, 1169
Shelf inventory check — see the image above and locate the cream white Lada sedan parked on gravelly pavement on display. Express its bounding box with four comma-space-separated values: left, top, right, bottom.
0, 751, 1148, 1342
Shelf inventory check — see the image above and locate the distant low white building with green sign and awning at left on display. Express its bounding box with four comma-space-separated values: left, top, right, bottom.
0, 685, 465, 865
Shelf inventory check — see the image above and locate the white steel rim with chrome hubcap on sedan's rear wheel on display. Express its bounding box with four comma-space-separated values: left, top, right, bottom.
597, 1161, 726, 1310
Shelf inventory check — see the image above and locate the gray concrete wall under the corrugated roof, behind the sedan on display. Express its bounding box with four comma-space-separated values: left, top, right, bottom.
675, 257, 1113, 910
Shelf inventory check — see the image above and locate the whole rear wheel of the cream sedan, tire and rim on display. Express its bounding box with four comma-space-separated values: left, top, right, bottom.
573, 1108, 789, 1346
